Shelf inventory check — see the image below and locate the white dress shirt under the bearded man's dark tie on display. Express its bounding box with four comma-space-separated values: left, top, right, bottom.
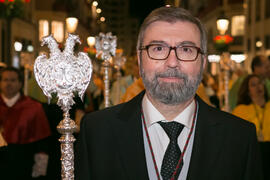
142, 94, 196, 177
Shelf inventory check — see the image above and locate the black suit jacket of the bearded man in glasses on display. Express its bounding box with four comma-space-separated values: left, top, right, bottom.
75, 92, 262, 180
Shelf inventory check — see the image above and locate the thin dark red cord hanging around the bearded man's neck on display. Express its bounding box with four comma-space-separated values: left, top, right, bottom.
141, 102, 197, 180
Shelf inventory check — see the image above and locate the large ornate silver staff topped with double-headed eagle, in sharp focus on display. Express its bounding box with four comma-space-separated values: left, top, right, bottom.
34, 34, 92, 180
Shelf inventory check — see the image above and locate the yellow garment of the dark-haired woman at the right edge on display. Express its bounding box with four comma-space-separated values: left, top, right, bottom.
232, 102, 270, 141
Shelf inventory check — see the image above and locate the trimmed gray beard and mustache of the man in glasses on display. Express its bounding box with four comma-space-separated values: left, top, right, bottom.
140, 67, 203, 105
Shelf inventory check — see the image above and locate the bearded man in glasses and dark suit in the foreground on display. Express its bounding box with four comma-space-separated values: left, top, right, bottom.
75, 7, 262, 180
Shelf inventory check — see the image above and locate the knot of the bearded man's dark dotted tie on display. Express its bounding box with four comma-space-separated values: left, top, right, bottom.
158, 121, 184, 140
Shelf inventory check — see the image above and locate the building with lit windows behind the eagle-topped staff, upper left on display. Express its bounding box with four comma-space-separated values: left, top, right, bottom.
0, 0, 91, 67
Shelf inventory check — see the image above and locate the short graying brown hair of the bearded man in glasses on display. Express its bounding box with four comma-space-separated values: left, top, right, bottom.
137, 7, 207, 54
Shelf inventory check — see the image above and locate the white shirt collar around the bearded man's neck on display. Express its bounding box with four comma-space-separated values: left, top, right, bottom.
142, 94, 195, 129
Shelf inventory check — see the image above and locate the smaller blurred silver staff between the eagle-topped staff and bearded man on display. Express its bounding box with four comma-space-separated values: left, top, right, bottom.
95, 32, 117, 107
